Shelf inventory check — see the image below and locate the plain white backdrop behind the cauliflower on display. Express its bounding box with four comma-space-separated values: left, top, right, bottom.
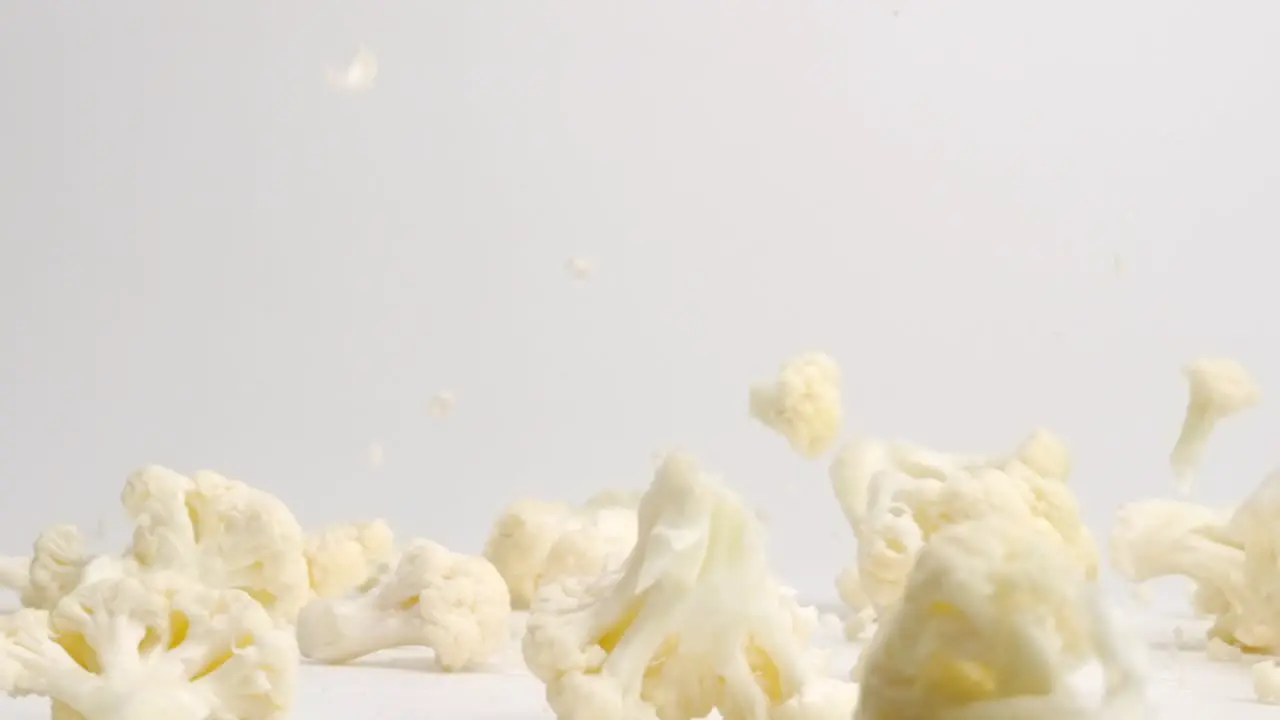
0, 0, 1280, 594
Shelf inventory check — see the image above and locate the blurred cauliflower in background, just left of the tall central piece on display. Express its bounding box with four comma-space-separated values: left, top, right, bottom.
484, 491, 636, 610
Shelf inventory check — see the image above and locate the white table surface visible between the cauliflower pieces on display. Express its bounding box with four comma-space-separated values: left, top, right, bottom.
0, 602, 1280, 720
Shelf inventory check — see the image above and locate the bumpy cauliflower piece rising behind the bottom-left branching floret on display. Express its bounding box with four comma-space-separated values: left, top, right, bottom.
120, 465, 311, 623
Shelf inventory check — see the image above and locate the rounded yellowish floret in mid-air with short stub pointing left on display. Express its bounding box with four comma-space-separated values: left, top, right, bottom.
749, 352, 844, 457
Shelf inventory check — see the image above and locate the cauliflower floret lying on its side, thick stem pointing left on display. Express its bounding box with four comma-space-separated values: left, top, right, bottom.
298, 541, 511, 670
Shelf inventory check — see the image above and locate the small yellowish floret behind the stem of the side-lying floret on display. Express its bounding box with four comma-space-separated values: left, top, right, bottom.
305, 520, 396, 597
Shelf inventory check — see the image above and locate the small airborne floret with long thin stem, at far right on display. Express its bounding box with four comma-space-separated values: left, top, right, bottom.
1169, 357, 1262, 495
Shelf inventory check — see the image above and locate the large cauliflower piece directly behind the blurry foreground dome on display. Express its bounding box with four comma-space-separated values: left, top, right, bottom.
831, 430, 1098, 635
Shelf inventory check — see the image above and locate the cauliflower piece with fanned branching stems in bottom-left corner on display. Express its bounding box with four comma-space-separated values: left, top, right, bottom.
0, 575, 298, 720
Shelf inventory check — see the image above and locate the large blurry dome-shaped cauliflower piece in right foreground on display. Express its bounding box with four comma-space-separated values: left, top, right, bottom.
855, 518, 1144, 720
